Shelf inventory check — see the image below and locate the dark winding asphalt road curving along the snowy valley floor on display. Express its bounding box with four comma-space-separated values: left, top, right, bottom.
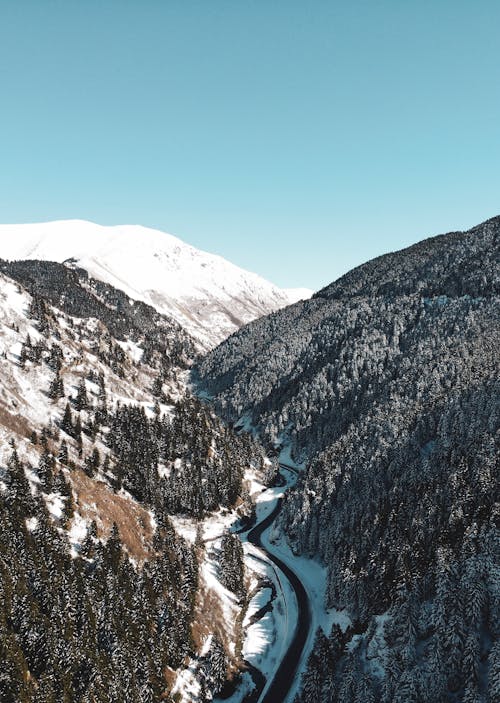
247, 486, 312, 703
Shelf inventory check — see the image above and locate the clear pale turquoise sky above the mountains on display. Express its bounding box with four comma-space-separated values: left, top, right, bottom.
0, 0, 500, 288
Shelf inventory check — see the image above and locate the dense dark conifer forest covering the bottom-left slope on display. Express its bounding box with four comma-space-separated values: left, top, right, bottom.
0, 462, 197, 703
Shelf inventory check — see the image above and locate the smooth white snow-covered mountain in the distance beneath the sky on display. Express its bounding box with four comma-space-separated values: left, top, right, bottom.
0, 220, 311, 349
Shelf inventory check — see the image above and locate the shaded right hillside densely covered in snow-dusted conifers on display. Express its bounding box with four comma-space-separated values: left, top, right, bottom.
193, 218, 500, 703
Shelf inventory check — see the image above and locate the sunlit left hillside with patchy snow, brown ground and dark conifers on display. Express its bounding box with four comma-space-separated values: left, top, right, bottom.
0, 262, 263, 703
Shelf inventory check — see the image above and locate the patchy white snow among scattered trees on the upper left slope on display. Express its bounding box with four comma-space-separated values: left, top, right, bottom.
0, 274, 175, 556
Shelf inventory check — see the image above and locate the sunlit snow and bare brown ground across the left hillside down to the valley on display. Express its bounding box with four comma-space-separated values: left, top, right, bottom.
0, 264, 258, 703
